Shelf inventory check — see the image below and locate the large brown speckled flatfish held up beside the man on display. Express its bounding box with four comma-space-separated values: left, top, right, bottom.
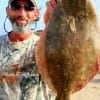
36, 0, 98, 100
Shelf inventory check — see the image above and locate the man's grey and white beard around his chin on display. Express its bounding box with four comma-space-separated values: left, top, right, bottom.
10, 16, 33, 34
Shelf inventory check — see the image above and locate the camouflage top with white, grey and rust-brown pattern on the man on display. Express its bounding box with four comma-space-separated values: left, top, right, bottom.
0, 33, 55, 100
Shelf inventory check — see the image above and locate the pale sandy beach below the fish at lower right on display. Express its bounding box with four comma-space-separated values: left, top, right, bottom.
71, 73, 100, 100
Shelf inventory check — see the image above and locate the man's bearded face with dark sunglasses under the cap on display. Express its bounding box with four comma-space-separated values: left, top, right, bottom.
7, 0, 39, 33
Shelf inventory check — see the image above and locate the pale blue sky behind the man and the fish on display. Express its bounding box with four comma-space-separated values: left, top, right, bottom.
0, 0, 100, 35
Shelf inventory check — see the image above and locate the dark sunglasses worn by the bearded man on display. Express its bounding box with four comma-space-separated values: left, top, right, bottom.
10, 3, 35, 11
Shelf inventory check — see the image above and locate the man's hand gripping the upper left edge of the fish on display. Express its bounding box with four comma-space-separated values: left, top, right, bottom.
44, 0, 57, 26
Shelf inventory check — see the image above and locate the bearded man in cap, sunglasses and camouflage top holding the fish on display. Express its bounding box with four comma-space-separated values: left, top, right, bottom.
0, 0, 54, 100
